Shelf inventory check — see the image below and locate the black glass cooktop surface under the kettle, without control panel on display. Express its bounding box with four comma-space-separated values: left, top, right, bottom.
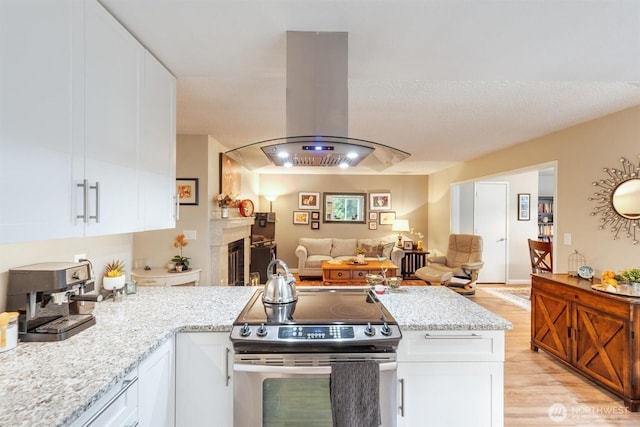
234, 288, 395, 325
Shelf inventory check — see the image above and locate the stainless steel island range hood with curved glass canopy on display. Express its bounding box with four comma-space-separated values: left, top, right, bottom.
225, 31, 410, 171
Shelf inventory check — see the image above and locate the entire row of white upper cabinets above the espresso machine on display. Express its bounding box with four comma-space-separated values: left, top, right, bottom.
0, 0, 175, 244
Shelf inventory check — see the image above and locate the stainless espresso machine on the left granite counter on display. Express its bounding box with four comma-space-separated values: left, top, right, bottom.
7, 261, 102, 341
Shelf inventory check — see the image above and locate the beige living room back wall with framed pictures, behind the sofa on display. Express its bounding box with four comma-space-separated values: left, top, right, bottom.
259, 174, 429, 269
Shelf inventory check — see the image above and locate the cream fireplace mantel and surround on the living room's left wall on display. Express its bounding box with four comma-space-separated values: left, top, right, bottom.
209, 212, 254, 286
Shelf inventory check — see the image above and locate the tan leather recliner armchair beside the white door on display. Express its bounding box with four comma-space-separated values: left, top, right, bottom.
415, 234, 484, 295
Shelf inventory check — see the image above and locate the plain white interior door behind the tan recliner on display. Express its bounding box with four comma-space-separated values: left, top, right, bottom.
473, 182, 509, 283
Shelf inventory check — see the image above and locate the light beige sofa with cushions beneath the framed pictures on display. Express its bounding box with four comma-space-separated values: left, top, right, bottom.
296, 236, 404, 278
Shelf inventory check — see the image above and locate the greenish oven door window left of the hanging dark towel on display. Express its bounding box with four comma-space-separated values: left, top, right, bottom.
262, 377, 333, 427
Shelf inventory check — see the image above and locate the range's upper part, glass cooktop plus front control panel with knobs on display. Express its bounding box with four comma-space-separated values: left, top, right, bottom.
231, 288, 402, 353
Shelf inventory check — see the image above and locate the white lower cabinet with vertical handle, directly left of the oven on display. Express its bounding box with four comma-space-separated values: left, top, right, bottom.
176, 332, 233, 427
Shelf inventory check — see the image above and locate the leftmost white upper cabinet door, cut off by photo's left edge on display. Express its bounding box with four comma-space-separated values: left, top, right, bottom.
0, 0, 83, 243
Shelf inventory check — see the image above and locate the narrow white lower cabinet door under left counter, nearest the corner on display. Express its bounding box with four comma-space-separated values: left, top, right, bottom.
138, 339, 175, 427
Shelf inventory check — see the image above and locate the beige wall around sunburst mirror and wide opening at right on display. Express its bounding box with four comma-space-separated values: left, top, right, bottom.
428, 107, 640, 274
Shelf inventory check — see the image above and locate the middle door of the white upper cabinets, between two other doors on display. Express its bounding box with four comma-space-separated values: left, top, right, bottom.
79, 1, 144, 236
